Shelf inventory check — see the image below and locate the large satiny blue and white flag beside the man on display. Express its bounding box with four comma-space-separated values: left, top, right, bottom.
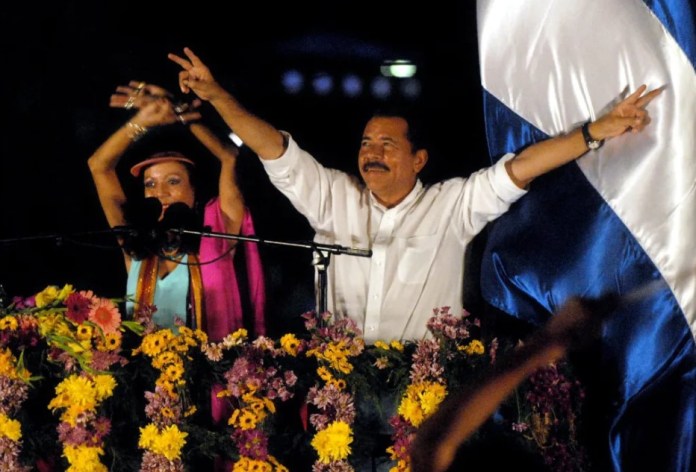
478, 0, 696, 471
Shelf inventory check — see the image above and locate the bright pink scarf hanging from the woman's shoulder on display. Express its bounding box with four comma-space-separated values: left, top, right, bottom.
199, 198, 266, 341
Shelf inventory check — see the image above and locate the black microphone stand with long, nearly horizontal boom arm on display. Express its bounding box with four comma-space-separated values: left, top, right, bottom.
174, 228, 372, 314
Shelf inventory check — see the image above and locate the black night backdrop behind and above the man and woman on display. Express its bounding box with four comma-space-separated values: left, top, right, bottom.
0, 0, 488, 324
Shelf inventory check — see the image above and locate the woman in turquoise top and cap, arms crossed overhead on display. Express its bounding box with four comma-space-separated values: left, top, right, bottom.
88, 81, 265, 340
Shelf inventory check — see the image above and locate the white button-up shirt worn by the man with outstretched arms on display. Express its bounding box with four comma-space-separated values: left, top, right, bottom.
262, 136, 526, 343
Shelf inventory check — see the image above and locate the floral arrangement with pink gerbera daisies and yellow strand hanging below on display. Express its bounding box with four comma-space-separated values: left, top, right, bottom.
3, 285, 137, 472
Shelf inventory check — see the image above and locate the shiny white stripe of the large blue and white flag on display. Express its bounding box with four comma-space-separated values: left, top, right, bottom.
478, 0, 696, 335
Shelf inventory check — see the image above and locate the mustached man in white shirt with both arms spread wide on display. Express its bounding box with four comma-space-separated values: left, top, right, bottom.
169, 48, 659, 343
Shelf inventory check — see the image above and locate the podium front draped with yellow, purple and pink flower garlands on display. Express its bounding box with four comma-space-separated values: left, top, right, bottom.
0, 285, 584, 471
